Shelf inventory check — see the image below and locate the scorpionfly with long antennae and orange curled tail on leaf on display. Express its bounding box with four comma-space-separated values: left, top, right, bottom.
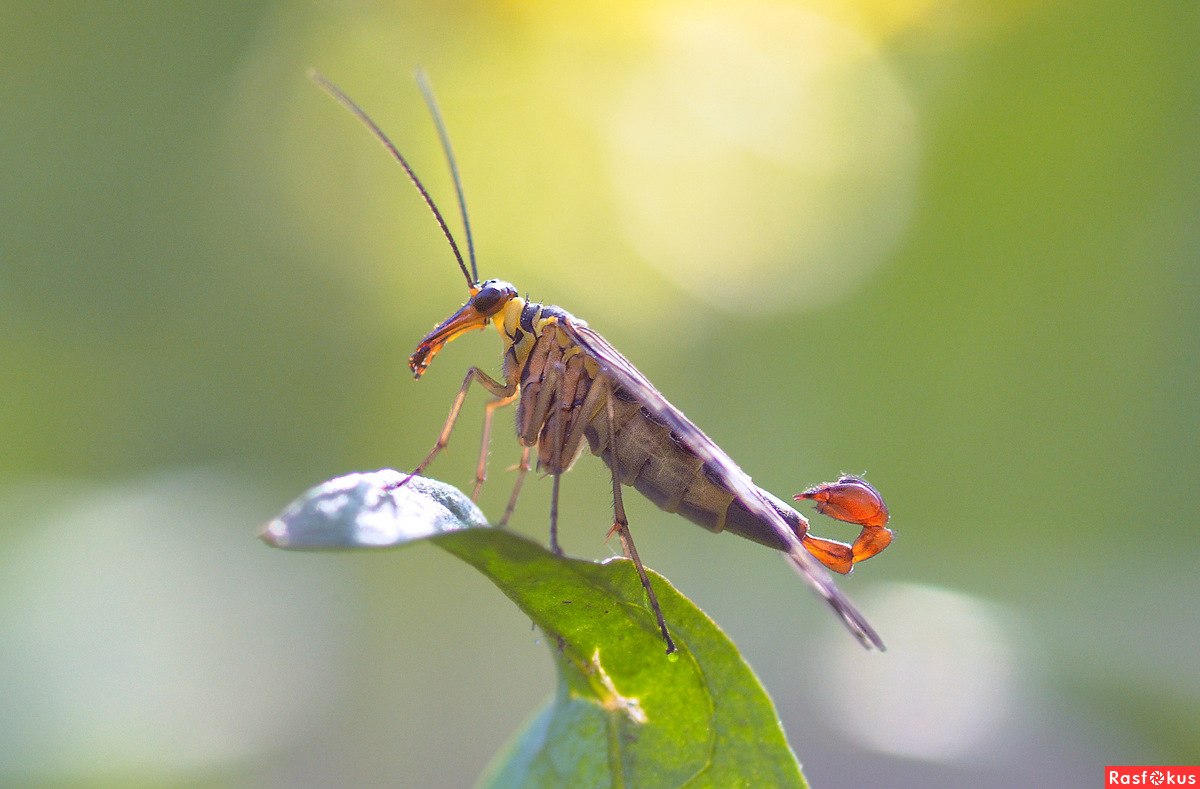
310, 72, 892, 654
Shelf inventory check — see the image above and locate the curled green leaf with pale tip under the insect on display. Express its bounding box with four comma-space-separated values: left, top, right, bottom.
262, 470, 805, 787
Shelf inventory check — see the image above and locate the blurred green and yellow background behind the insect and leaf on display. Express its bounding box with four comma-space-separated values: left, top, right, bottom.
0, 0, 1200, 787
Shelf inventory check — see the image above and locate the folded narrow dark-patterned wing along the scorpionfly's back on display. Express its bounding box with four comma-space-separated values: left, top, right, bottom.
559, 314, 884, 651
